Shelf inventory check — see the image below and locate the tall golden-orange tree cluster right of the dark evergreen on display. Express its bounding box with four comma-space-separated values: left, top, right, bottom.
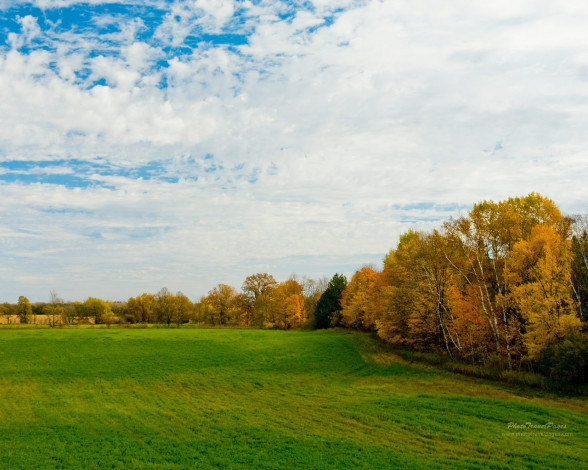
331, 194, 588, 380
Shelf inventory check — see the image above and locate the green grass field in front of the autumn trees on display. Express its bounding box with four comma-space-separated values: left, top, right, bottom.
0, 329, 588, 469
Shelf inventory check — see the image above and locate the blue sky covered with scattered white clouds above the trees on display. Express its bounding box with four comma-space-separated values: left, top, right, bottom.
0, 0, 588, 302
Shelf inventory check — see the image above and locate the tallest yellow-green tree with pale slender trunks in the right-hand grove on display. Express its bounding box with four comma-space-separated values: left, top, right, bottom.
444, 193, 570, 367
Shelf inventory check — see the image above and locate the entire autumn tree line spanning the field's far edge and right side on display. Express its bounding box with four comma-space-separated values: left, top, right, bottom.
0, 193, 588, 380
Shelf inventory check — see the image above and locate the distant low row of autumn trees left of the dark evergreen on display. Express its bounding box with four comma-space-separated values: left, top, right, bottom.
0, 273, 326, 329
